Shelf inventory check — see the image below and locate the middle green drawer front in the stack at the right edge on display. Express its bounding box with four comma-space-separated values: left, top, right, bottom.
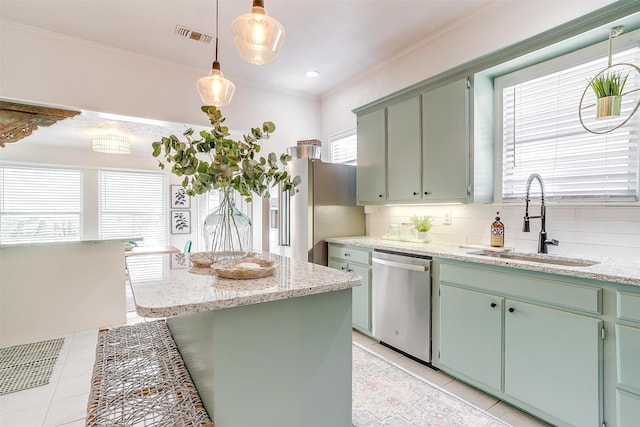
616, 325, 640, 393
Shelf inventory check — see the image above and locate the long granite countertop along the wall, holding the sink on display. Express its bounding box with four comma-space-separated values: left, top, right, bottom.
325, 236, 640, 286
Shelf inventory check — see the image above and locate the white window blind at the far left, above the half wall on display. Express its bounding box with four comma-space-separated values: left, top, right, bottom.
0, 166, 82, 244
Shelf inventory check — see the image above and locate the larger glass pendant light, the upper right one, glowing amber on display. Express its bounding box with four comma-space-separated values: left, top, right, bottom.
231, 0, 284, 65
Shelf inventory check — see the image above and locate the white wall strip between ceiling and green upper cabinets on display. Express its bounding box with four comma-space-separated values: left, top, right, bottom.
321, 0, 614, 145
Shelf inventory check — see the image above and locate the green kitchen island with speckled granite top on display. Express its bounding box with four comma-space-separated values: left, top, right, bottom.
131, 254, 360, 427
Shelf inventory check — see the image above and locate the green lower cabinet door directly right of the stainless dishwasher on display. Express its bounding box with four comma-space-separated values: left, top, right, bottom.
440, 284, 503, 390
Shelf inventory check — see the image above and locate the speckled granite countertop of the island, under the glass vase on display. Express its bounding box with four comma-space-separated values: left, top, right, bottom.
129, 253, 360, 317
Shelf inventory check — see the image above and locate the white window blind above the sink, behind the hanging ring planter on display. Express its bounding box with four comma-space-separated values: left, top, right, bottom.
496, 43, 640, 201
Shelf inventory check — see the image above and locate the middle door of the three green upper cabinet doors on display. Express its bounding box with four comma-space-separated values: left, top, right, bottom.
387, 96, 422, 201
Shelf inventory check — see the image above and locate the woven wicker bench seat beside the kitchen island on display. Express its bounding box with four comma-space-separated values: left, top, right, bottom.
86, 321, 214, 427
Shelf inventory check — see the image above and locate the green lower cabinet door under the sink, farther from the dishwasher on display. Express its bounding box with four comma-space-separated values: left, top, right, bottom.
504, 300, 603, 427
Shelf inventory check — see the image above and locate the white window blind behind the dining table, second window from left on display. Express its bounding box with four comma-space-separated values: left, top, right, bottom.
98, 170, 169, 282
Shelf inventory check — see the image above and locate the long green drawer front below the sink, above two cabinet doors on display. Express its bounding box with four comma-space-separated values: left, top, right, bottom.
440, 263, 602, 314
